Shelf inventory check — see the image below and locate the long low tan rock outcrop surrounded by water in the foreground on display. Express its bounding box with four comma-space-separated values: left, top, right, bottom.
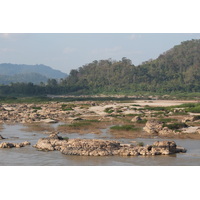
34, 134, 186, 156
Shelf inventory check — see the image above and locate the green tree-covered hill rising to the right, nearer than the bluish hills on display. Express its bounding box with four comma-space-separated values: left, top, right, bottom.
62, 40, 200, 93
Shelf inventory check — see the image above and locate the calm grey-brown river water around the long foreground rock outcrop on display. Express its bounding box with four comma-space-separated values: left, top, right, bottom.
0, 124, 200, 166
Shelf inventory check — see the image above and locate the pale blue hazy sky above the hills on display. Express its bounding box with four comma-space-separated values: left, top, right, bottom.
0, 33, 200, 73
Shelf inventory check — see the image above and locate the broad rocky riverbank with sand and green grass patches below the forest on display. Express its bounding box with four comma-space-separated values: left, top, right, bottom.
0, 100, 200, 139
